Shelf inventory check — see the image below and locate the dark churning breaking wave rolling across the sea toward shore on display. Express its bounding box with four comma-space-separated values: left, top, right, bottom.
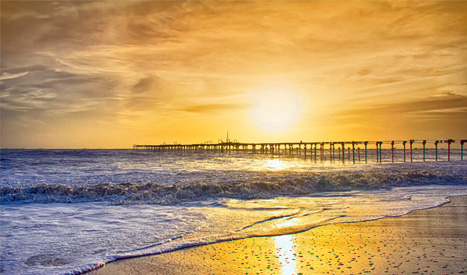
0, 169, 467, 205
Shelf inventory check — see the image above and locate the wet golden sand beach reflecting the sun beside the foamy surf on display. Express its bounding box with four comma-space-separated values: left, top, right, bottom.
91, 196, 467, 275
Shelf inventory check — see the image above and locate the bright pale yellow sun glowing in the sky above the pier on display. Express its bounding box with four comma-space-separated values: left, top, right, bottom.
251, 85, 301, 132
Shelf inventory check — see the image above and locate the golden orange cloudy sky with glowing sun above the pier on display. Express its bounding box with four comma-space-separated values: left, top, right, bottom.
0, 0, 467, 148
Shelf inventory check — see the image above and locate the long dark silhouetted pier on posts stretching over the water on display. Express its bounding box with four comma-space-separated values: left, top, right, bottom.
133, 139, 467, 163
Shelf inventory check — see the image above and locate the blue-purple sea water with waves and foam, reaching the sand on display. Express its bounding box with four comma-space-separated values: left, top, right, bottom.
0, 150, 467, 274
